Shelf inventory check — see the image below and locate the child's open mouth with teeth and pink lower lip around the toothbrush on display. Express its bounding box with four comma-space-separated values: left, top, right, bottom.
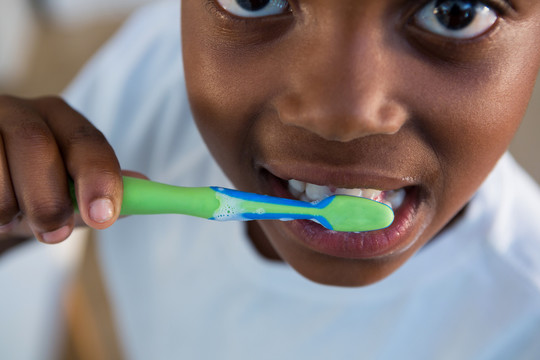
263, 171, 422, 259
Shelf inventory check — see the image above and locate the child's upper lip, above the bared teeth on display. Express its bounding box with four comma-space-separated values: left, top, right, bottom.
256, 160, 418, 191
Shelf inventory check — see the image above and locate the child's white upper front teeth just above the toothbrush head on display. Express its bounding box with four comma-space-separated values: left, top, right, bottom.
289, 179, 405, 209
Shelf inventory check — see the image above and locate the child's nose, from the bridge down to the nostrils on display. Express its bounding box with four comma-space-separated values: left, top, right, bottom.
276, 20, 408, 142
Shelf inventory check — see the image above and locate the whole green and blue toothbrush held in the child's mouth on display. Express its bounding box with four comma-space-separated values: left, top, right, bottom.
70, 176, 394, 232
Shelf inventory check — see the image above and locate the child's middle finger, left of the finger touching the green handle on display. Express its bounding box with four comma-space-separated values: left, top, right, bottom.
0, 99, 73, 243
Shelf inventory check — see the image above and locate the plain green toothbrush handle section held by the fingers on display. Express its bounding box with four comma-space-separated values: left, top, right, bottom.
70, 176, 220, 219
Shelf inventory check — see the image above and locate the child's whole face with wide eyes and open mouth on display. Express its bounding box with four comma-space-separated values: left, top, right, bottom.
182, 0, 540, 286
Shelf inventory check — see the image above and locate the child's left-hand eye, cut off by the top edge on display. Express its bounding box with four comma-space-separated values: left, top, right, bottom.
216, 0, 289, 17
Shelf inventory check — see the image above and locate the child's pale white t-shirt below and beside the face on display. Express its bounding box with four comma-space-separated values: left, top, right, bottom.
0, 1, 540, 360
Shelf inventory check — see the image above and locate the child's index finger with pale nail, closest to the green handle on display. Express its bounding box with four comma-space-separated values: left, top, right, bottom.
38, 98, 123, 229
